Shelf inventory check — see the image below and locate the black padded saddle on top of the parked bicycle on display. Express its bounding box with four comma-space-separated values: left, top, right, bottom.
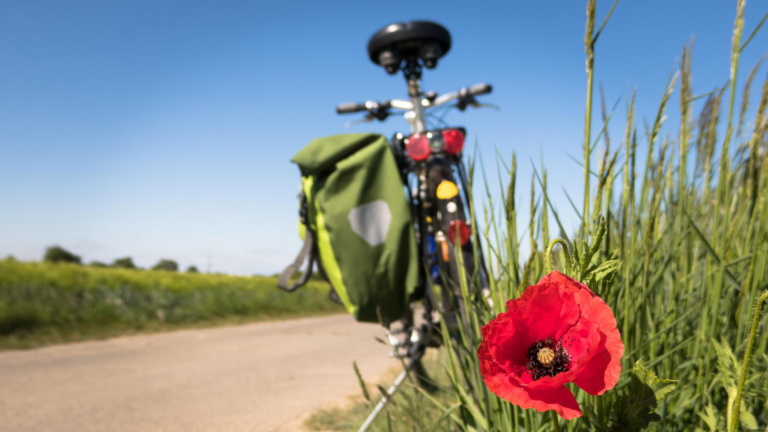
368, 21, 451, 75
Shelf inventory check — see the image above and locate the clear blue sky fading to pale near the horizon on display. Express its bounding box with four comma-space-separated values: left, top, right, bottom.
0, 0, 768, 274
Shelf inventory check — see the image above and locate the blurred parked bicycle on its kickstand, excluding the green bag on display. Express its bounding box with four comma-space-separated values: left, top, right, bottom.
336, 21, 492, 431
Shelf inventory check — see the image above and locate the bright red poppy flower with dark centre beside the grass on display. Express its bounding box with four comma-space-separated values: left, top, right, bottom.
477, 271, 624, 420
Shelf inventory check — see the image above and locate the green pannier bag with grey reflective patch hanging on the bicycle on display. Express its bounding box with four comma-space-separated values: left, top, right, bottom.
278, 134, 419, 322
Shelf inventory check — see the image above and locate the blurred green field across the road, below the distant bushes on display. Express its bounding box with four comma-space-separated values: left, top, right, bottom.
0, 260, 343, 349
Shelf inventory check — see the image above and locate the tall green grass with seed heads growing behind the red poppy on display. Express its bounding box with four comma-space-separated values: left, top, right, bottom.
428, 0, 768, 431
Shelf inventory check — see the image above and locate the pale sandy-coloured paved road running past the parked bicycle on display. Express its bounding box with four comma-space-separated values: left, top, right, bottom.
0, 315, 397, 432
